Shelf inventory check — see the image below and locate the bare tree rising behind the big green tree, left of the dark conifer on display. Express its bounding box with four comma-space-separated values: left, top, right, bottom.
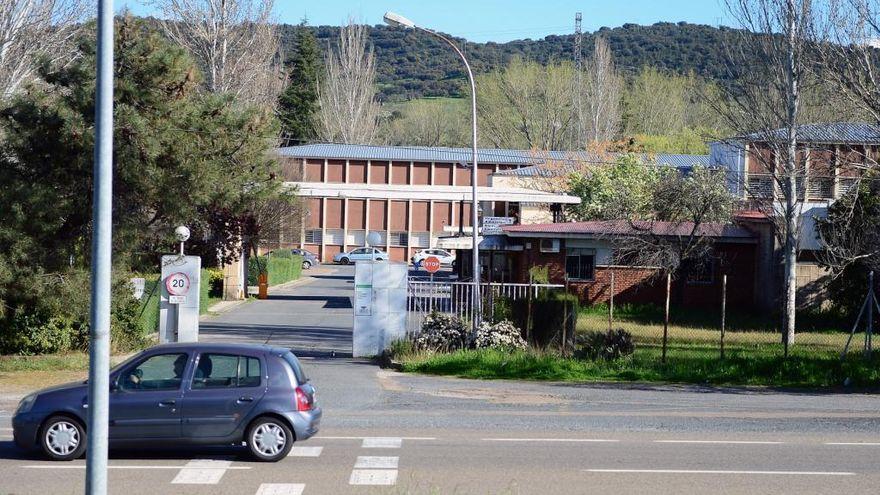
150, 0, 284, 108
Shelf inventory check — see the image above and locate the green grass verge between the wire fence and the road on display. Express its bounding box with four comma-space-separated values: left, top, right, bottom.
400, 347, 880, 389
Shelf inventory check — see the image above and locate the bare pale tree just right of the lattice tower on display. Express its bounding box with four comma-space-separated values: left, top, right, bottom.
576, 37, 621, 147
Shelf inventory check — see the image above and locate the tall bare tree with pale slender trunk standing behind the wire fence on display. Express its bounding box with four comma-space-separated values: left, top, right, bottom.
718, 0, 820, 354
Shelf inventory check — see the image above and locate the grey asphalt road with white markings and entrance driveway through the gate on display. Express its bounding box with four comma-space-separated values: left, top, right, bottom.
0, 267, 880, 495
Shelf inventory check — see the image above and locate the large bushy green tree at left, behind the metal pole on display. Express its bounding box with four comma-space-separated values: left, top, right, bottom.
0, 16, 280, 352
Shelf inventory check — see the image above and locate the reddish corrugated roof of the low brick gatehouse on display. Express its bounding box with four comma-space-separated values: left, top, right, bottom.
503, 220, 754, 239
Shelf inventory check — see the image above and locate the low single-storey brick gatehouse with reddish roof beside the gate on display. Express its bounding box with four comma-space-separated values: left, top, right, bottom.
504, 221, 768, 306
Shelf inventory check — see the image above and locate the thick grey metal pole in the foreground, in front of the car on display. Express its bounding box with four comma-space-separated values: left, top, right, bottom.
85, 0, 113, 495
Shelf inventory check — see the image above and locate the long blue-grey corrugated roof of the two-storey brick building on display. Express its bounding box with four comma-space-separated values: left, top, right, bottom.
278, 143, 709, 168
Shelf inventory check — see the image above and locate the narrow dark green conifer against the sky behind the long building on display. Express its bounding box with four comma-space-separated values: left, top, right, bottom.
278, 21, 323, 143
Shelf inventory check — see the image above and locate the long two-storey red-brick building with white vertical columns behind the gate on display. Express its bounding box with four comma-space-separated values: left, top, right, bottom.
279, 144, 580, 261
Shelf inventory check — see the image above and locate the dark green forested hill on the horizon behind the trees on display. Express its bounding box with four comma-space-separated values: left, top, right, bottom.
281, 22, 731, 100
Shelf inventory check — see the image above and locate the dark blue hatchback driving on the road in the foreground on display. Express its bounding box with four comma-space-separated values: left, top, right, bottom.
12, 343, 322, 462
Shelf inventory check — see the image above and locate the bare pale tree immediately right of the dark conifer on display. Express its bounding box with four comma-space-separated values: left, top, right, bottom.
318, 20, 380, 144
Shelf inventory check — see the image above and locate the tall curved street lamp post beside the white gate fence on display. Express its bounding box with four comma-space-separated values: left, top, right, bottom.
384, 12, 482, 330
